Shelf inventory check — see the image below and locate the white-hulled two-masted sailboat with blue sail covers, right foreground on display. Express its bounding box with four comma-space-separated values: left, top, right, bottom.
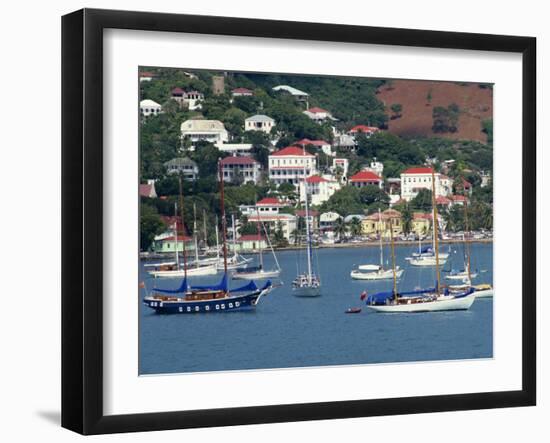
366, 170, 475, 313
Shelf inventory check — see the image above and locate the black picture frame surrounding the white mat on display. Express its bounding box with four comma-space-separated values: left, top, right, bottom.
62, 9, 536, 434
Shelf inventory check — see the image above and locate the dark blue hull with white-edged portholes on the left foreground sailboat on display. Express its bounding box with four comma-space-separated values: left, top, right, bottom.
143, 289, 269, 314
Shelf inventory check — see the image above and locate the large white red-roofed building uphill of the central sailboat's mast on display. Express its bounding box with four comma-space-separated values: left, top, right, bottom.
269, 146, 317, 186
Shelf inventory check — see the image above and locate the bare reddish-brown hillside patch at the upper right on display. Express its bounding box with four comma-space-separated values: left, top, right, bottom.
378, 80, 493, 143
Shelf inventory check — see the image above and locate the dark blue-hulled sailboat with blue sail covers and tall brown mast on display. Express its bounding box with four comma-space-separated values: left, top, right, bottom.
143, 163, 273, 314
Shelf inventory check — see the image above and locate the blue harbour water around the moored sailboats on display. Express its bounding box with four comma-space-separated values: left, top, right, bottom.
139, 243, 493, 374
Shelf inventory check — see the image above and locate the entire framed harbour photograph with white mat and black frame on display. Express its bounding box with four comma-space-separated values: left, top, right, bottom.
62, 9, 536, 434
